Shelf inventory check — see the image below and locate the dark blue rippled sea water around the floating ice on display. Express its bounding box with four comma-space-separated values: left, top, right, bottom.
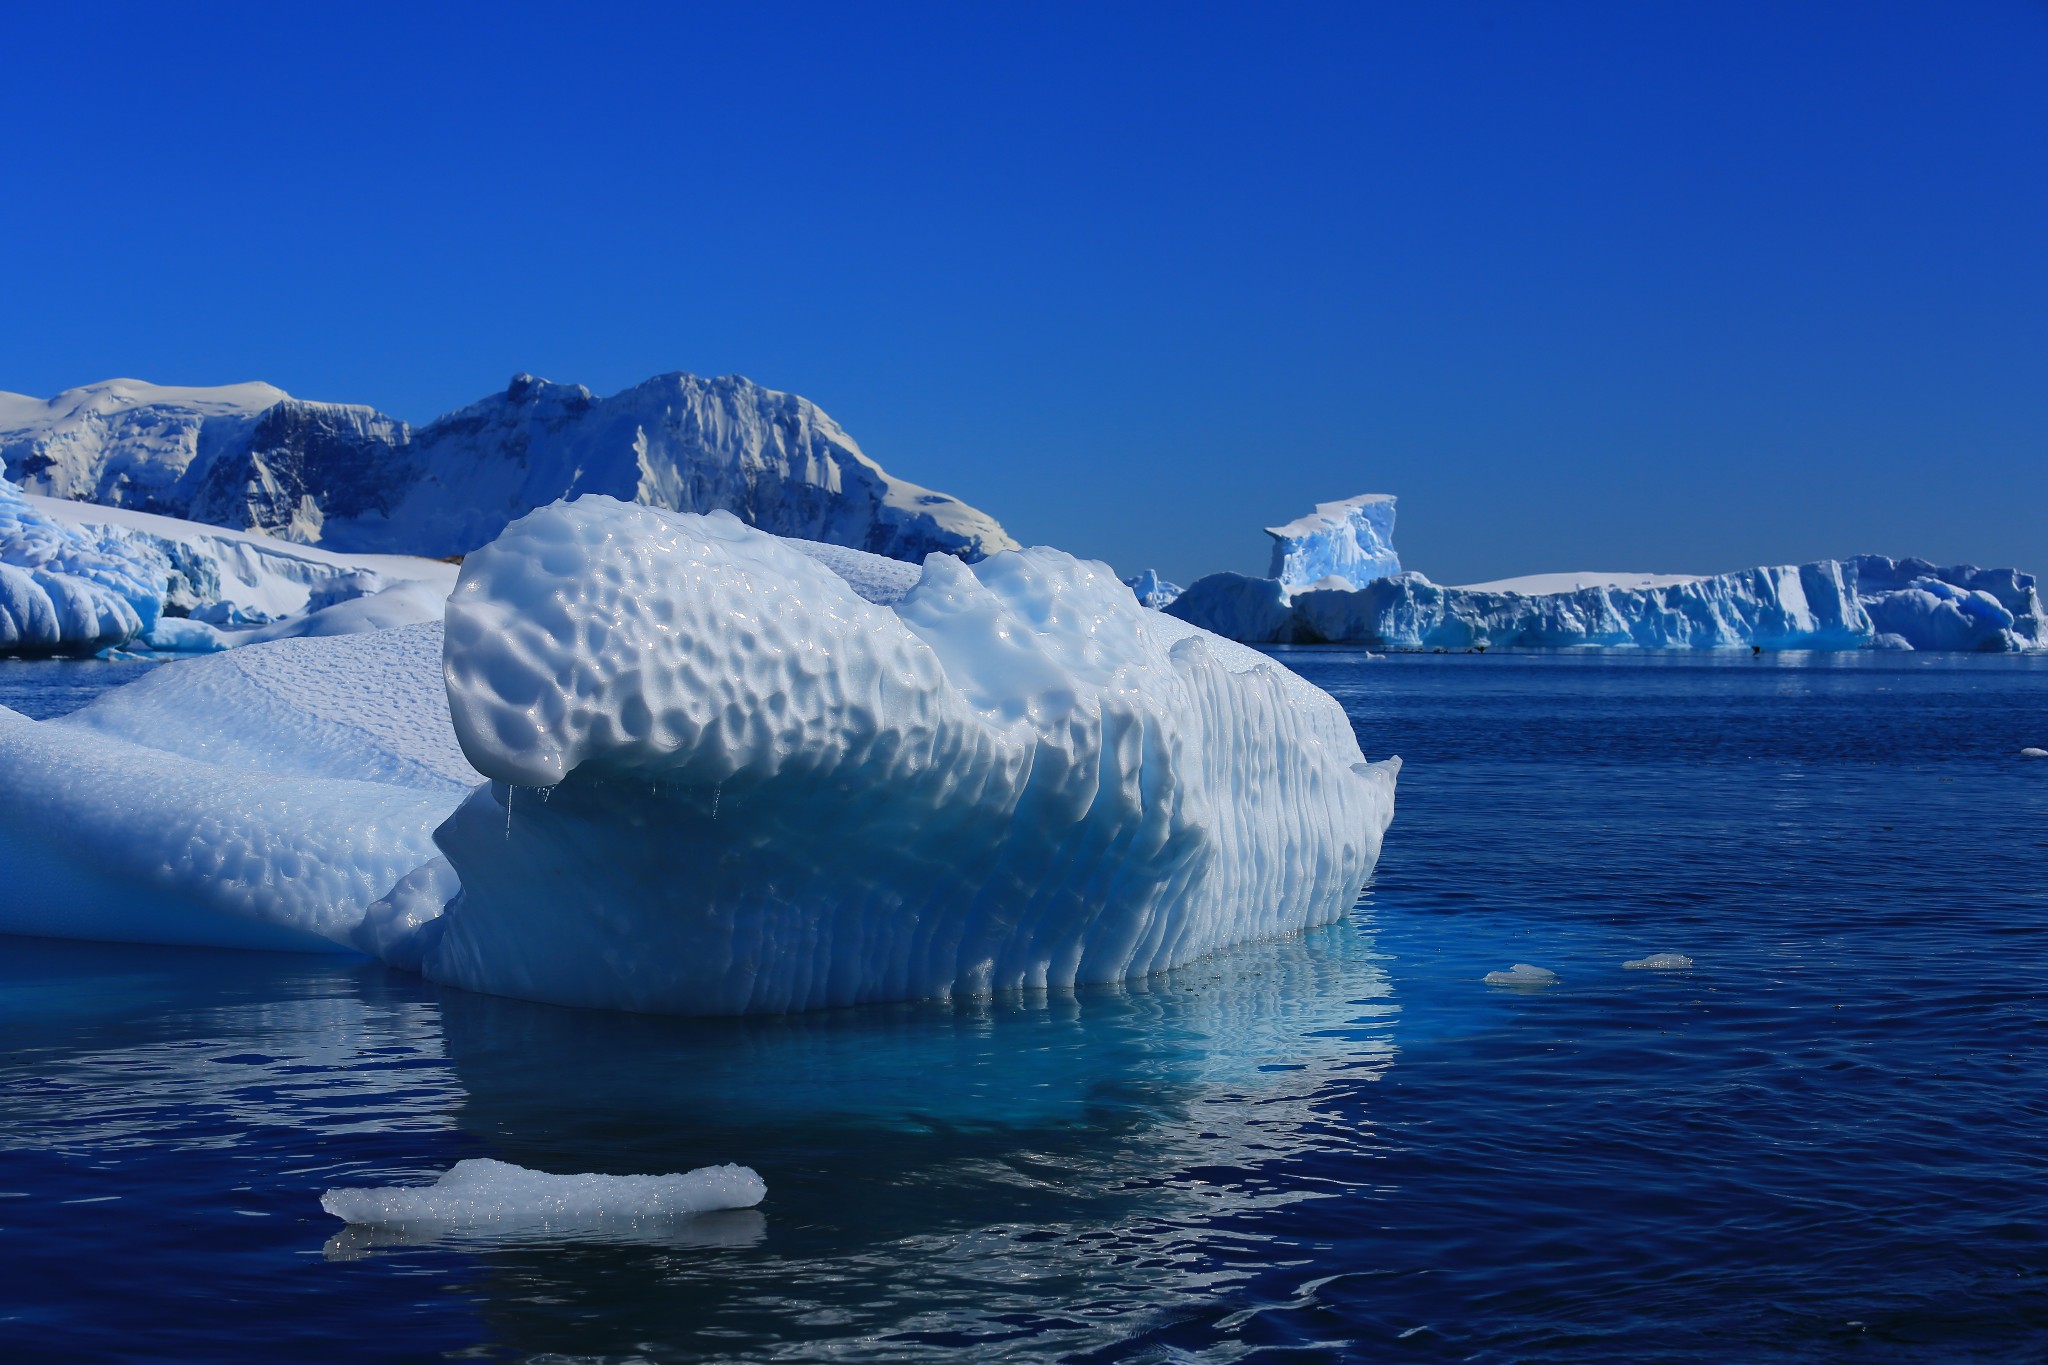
0, 651, 2048, 1361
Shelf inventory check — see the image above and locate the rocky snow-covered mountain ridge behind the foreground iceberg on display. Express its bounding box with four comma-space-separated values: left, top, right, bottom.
0, 375, 1016, 561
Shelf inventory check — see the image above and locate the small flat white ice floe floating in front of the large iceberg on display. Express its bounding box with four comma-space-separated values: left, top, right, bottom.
319, 1158, 768, 1232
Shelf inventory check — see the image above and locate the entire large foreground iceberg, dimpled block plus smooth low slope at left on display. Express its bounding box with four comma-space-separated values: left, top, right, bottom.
0, 497, 1399, 1013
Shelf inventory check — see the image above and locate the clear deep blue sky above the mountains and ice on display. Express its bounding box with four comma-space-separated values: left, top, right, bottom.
0, 0, 2048, 583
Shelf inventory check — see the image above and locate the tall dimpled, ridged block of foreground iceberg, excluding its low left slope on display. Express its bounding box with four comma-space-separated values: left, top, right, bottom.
420, 497, 1397, 1013
